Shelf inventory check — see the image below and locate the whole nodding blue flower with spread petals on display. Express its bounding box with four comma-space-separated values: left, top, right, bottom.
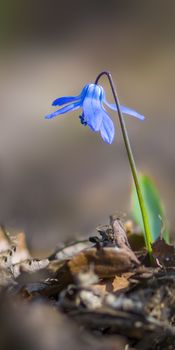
45, 84, 144, 144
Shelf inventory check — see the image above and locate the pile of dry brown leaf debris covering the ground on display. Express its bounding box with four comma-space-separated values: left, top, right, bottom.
0, 216, 175, 350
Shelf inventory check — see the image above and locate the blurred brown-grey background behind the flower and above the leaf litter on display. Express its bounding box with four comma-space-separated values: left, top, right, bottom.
0, 0, 175, 251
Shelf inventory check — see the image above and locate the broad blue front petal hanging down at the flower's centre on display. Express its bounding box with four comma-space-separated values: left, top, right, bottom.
83, 84, 103, 131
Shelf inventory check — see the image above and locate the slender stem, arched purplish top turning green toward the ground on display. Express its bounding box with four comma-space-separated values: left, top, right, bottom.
95, 71, 152, 256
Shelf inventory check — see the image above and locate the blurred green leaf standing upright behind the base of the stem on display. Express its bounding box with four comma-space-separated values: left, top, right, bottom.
131, 174, 170, 243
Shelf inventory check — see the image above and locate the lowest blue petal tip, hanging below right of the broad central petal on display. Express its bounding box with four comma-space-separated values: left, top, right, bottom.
100, 113, 115, 144
